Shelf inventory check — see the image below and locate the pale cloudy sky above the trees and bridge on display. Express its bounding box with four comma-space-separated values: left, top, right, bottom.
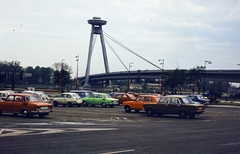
0, 0, 240, 76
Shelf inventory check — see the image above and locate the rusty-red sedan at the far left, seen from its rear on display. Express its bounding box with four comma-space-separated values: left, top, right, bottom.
0, 93, 52, 118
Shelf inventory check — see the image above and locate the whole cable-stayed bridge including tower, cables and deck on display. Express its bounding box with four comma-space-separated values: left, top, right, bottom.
78, 17, 240, 86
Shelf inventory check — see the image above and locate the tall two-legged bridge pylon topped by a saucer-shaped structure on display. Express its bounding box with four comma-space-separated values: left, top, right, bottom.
84, 17, 109, 86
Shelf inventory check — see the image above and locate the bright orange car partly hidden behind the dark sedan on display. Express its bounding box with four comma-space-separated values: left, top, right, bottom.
123, 95, 161, 112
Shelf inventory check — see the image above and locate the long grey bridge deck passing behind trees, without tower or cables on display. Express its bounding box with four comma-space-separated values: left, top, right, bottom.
79, 70, 240, 86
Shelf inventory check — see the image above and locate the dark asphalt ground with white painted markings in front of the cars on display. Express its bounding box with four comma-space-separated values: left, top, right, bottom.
0, 106, 240, 154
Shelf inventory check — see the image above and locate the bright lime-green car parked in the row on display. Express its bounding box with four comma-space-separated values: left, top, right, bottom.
82, 93, 118, 108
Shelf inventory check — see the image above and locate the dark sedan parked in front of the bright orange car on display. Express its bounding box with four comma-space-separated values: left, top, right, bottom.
143, 95, 205, 118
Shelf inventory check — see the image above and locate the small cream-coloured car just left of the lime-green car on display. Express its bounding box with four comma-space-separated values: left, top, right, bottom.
52, 92, 82, 107
